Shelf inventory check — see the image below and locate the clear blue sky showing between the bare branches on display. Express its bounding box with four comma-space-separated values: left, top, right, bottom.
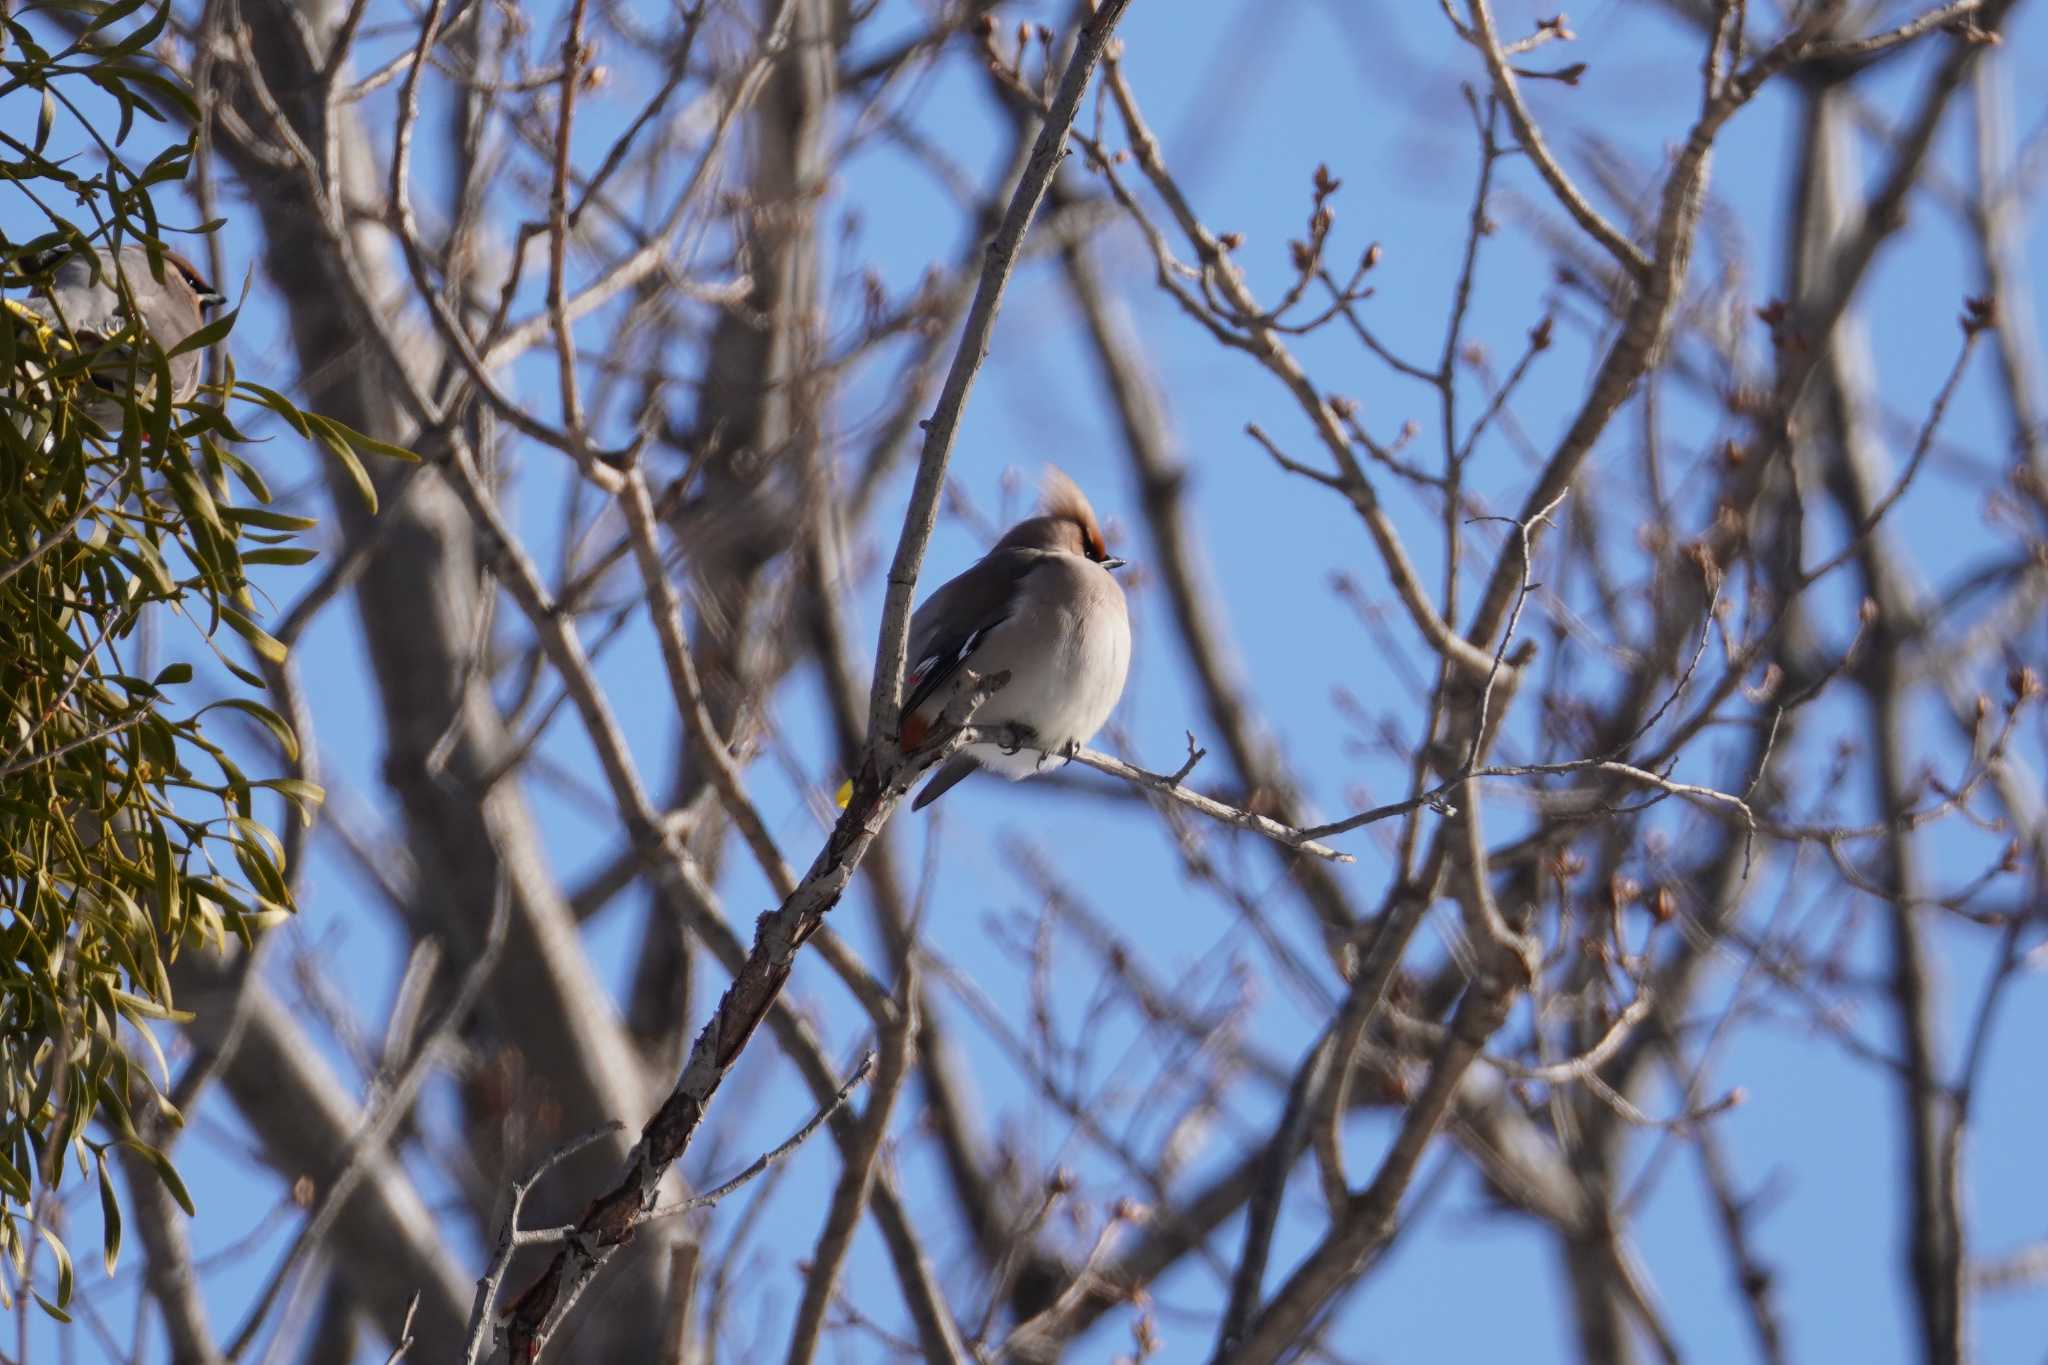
0, 0, 2048, 1363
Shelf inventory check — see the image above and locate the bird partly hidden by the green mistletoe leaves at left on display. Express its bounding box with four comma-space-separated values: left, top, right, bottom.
8, 244, 223, 422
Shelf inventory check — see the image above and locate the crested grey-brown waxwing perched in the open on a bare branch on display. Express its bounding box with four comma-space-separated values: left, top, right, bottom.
901, 467, 1130, 810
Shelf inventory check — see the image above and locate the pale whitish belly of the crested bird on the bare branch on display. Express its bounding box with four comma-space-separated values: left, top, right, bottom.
967, 604, 1130, 782
